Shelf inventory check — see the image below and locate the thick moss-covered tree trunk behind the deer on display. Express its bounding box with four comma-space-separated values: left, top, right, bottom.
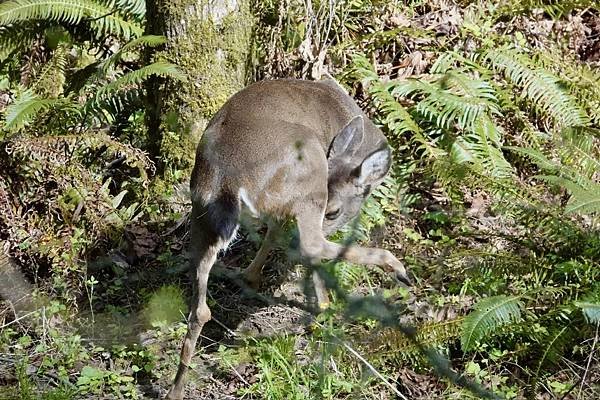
146, 0, 252, 178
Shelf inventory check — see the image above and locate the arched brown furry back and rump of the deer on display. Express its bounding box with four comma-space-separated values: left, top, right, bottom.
191, 80, 386, 213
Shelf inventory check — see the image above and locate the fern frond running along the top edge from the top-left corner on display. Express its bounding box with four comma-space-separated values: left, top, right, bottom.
0, 0, 142, 39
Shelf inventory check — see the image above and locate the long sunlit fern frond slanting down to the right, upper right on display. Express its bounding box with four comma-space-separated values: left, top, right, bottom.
483, 49, 590, 127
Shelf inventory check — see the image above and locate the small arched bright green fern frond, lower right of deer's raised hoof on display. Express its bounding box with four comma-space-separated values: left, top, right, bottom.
461, 296, 523, 351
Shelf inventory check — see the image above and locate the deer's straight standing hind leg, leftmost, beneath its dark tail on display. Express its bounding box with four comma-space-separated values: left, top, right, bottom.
167, 196, 239, 400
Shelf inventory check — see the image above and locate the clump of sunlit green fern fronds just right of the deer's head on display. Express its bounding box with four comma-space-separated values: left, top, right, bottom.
353, 53, 512, 178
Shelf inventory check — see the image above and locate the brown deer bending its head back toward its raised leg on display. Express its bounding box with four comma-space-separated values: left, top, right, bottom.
166, 79, 411, 399
